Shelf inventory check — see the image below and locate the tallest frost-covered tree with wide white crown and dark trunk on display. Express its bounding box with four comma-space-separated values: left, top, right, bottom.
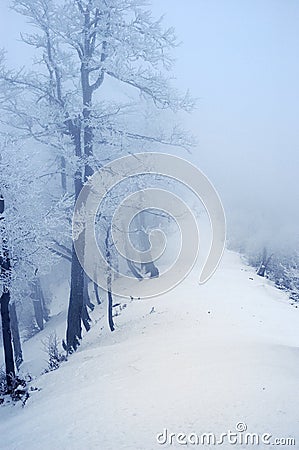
0, 0, 193, 351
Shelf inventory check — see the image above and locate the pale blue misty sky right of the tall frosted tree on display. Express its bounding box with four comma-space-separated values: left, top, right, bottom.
0, 0, 299, 250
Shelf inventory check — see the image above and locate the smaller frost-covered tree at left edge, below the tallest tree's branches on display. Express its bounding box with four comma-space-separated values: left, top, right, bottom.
0, 140, 65, 376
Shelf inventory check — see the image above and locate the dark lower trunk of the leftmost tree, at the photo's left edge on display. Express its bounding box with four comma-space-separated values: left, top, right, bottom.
0, 290, 15, 392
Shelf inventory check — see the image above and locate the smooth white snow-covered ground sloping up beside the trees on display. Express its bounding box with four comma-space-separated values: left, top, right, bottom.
0, 251, 299, 450
